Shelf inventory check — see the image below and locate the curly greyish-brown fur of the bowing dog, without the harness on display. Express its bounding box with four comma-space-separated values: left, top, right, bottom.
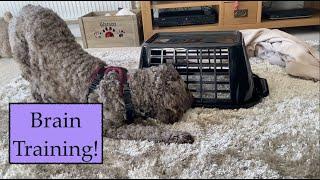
9, 5, 193, 143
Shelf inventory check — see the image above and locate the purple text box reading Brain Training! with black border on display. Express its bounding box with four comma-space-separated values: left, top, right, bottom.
9, 103, 103, 164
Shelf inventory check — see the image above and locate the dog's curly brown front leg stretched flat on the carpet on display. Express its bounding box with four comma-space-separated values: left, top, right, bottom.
104, 124, 194, 144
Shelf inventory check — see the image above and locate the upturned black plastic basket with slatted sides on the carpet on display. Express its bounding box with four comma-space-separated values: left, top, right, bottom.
140, 31, 269, 108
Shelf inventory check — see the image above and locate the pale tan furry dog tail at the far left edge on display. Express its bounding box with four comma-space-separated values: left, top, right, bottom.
0, 12, 12, 57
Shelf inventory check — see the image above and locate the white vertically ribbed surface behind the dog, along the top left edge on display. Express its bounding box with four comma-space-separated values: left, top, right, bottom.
0, 1, 133, 20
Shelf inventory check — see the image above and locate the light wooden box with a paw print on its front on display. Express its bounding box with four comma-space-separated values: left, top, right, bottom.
79, 10, 143, 48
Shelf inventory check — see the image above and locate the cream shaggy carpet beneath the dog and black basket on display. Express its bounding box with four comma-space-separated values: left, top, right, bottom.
0, 48, 320, 178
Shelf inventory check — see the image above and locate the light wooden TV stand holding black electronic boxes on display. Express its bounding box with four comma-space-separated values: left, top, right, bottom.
140, 1, 320, 40
